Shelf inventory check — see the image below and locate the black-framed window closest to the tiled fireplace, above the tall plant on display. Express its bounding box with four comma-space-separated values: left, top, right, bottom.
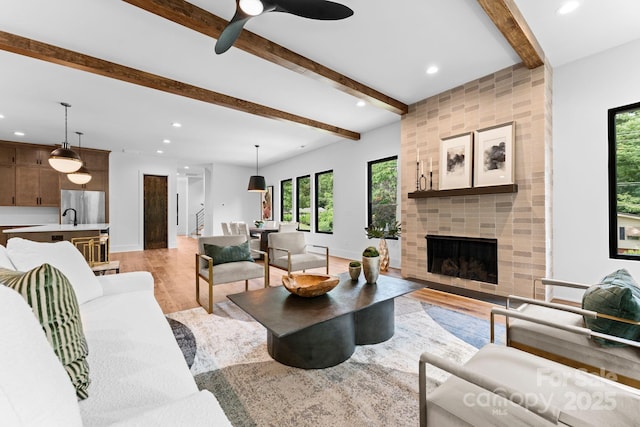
367, 156, 398, 232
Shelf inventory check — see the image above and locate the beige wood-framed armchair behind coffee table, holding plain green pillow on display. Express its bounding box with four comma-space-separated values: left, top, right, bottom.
195, 235, 269, 313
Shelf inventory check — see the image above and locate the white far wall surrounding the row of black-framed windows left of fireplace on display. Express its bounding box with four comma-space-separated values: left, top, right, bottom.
256, 121, 401, 268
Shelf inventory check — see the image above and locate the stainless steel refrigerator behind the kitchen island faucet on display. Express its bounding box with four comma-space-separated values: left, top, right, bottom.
60, 190, 106, 224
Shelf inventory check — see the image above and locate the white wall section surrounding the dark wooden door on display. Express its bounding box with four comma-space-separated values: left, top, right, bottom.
109, 152, 178, 252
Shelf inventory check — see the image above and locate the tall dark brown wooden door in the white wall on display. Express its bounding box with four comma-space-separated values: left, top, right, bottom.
144, 175, 169, 249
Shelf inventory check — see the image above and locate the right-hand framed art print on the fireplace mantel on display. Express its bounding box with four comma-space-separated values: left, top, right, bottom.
474, 122, 515, 187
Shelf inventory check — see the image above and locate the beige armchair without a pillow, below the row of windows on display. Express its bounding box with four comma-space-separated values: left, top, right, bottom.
268, 231, 329, 274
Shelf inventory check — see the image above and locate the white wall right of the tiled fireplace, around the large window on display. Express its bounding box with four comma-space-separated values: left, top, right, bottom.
553, 40, 640, 299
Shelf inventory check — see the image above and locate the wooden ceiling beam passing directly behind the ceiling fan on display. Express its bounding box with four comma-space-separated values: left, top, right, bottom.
123, 0, 409, 114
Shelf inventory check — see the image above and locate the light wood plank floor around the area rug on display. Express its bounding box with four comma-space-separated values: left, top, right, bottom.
111, 236, 494, 319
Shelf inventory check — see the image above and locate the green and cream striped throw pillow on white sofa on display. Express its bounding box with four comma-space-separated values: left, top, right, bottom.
0, 264, 89, 399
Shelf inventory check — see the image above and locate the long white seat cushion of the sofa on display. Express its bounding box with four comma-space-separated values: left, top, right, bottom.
78, 290, 198, 426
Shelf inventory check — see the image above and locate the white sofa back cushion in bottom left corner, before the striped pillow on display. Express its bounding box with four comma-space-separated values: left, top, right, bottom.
0, 285, 82, 427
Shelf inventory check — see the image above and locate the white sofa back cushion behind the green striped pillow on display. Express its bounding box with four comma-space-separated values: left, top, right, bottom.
7, 237, 102, 304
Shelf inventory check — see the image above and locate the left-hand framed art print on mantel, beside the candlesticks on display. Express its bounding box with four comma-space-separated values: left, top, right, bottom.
439, 132, 473, 190
